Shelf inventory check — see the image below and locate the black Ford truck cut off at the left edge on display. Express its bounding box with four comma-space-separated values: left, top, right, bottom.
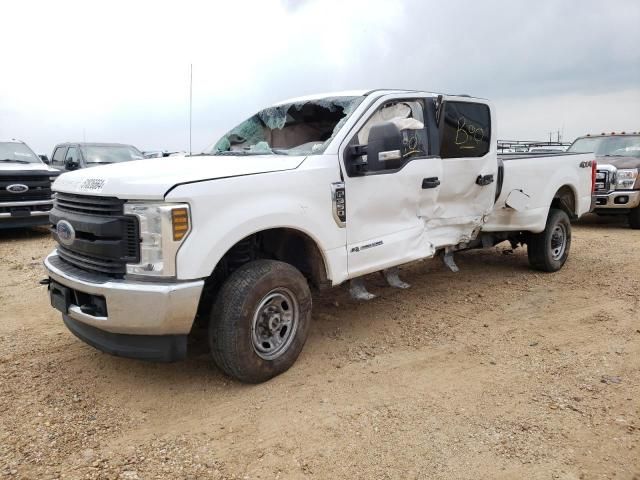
0, 139, 59, 229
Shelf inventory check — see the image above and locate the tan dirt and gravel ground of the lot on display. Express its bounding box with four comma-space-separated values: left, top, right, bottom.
0, 217, 640, 479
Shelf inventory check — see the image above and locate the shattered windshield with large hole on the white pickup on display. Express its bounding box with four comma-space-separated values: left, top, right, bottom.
205, 96, 364, 155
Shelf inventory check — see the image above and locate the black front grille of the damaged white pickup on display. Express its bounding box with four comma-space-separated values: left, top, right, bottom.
50, 192, 140, 278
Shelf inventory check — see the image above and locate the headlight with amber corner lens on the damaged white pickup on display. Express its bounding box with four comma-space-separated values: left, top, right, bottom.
124, 202, 191, 277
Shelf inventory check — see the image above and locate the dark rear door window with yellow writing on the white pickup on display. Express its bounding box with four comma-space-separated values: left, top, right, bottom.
440, 102, 491, 158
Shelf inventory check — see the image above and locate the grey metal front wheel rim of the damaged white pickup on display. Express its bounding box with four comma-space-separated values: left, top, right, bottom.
251, 288, 300, 360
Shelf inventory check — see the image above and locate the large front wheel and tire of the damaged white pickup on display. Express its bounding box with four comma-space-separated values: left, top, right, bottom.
209, 260, 311, 383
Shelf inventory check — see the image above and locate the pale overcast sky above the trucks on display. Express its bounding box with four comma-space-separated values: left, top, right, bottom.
0, 0, 640, 154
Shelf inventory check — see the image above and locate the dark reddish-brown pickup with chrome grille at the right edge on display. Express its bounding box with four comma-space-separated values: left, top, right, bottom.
568, 132, 640, 229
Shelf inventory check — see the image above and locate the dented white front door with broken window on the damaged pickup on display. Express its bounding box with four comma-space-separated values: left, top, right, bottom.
340, 95, 442, 278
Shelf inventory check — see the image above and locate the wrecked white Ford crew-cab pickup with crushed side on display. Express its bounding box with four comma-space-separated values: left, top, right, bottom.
44, 90, 595, 382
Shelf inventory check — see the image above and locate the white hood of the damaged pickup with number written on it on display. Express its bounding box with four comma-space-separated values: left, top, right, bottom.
53, 155, 305, 200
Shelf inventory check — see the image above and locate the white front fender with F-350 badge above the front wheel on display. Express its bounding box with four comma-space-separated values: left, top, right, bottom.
167, 157, 346, 280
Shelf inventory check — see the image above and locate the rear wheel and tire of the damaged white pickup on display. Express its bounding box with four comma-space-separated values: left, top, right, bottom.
527, 208, 571, 272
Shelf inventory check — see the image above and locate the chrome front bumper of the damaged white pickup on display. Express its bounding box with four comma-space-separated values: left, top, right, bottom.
44, 251, 204, 348
